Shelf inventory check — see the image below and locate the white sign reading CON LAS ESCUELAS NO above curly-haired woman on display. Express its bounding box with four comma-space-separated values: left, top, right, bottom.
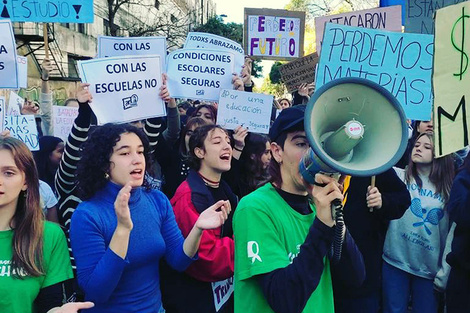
78, 56, 166, 124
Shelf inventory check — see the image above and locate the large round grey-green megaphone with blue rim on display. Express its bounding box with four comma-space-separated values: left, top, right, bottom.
300, 78, 408, 184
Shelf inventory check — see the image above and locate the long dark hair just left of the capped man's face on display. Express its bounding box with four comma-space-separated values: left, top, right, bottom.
240, 133, 269, 190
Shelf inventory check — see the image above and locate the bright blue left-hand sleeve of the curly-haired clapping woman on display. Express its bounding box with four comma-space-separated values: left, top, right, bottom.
70, 203, 128, 303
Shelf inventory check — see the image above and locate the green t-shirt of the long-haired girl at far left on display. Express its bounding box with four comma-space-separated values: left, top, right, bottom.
0, 222, 73, 313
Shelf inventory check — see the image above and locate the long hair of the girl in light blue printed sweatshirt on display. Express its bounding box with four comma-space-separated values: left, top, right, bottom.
405, 133, 455, 201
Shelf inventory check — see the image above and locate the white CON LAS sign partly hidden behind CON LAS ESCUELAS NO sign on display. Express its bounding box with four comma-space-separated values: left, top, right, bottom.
97, 36, 166, 69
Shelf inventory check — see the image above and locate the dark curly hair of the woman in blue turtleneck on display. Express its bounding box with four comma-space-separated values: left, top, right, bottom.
77, 123, 150, 200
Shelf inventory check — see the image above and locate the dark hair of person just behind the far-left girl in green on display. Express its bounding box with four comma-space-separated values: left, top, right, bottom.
33, 136, 63, 188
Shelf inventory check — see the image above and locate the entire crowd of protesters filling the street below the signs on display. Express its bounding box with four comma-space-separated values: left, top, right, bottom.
0, 54, 470, 313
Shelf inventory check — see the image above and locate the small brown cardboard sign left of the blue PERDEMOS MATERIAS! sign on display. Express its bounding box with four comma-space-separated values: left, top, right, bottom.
279, 52, 318, 92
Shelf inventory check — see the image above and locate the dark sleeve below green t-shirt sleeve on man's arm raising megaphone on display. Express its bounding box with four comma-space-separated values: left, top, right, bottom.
258, 219, 334, 313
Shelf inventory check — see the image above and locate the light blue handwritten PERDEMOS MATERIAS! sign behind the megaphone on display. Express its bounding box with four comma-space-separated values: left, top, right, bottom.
315, 23, 433, 121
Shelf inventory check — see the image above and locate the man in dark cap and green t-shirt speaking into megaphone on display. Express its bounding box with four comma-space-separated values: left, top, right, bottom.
233, 106, 365, 313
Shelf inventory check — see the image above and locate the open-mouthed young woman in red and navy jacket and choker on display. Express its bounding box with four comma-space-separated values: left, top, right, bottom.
163, 125, 237, 313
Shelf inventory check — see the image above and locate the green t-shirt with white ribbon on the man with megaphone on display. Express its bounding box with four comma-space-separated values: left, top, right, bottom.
233, 184, 334, 313
